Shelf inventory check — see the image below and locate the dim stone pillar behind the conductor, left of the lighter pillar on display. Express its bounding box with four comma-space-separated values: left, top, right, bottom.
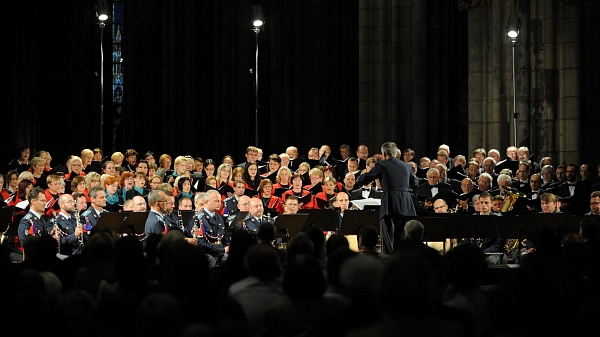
358, 0, 428, 155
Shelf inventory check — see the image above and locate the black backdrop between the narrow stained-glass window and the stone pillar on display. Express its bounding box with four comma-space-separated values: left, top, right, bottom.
117, 0, 358, 162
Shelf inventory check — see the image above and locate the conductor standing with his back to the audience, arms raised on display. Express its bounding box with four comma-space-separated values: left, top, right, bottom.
358, 142, 417, 254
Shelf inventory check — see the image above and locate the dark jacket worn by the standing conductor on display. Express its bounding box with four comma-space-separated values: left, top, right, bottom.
358, 158, 417, 219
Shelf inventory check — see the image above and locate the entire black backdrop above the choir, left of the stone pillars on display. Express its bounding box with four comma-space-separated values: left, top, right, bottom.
1, 0, 358, 167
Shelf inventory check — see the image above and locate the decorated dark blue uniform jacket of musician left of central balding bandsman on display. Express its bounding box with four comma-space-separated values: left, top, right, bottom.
197, 211, 229, 257
